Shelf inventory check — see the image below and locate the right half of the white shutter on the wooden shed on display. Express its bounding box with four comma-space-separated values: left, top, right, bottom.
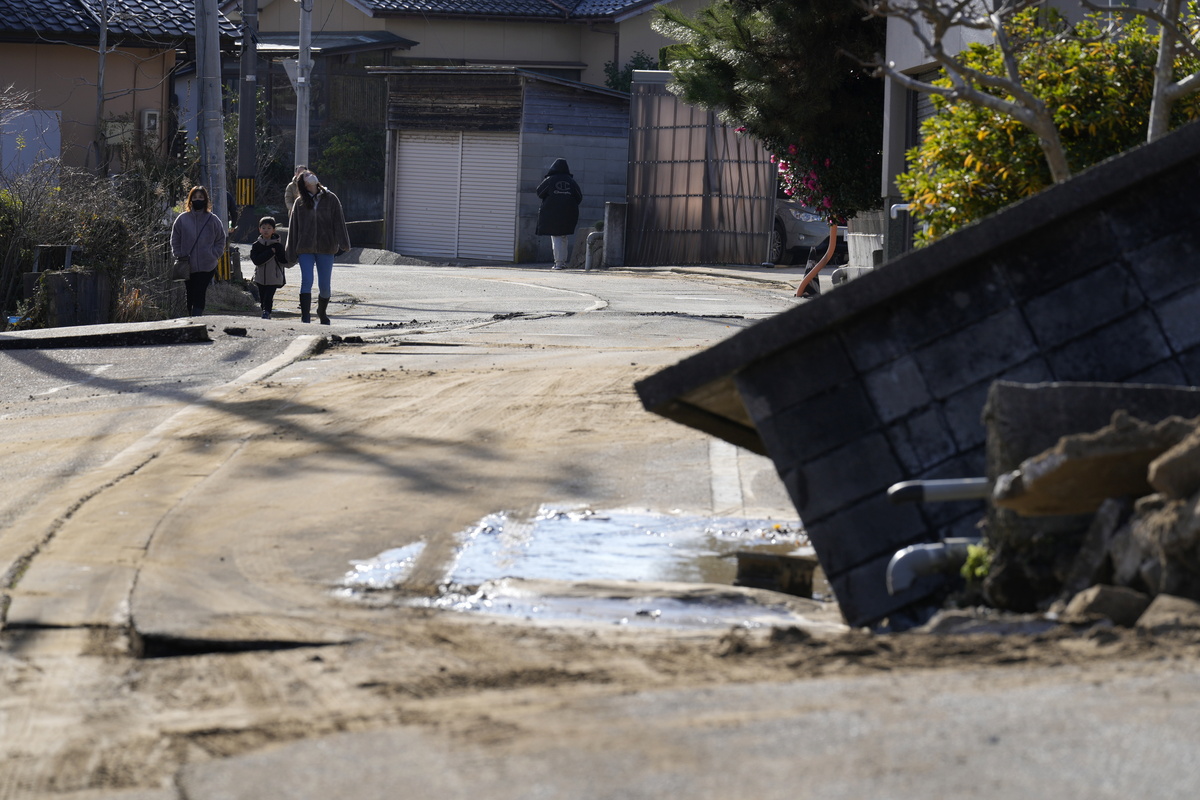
458, 133, 517, 261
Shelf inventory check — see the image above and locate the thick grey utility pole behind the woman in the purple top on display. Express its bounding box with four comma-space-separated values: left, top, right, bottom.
196, 0, 229, 232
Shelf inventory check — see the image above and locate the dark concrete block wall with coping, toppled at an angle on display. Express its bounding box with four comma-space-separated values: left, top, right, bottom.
638, 125, 1200, 624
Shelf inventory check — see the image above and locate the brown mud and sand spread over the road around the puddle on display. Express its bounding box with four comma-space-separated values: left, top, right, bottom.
0, 337, 1200, 798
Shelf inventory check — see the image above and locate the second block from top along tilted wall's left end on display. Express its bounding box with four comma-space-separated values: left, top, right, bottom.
755, 381, 880, 469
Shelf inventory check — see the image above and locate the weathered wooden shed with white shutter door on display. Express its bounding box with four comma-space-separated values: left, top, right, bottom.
372, 67, 629, 263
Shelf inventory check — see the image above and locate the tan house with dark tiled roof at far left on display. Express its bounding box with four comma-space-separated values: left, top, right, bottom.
0, 0, 236, 170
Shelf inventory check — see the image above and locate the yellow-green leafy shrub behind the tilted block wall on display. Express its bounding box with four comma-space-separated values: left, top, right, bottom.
896, 8, 1200, 243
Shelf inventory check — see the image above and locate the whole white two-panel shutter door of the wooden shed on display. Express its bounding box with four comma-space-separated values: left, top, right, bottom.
392, 131, 518, 261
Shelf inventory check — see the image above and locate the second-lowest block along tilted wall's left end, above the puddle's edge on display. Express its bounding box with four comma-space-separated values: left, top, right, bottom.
805, 492, 935, 579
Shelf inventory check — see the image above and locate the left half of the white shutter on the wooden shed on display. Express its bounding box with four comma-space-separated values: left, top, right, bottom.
392, 132, 461, 258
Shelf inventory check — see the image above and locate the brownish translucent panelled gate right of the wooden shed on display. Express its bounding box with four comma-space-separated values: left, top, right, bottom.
625, 72, 776, 266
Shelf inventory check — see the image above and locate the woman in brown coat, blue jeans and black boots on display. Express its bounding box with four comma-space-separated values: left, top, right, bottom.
287, 170, 350, 325
